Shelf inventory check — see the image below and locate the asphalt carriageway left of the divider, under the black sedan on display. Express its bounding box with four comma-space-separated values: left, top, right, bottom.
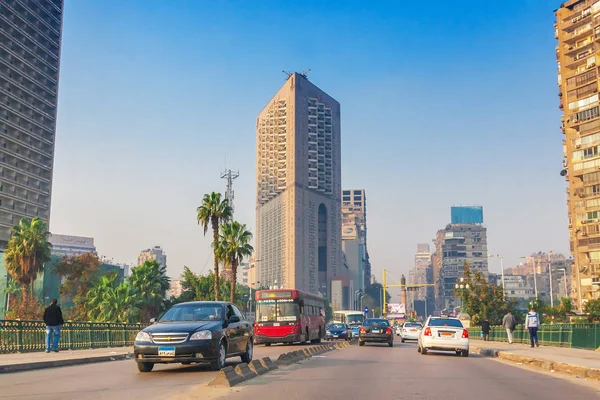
0, 345, 322, 400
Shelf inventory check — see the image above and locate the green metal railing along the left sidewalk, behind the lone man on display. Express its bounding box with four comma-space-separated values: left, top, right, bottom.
0, 320, 145, 354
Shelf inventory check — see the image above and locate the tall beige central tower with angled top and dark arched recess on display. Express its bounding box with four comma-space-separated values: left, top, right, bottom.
255, 73, 343, 295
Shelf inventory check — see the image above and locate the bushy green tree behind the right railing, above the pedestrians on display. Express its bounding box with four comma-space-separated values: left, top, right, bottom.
455, 263, 514, 325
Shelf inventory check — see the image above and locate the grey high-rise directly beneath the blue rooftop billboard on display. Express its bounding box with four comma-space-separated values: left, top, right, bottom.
434, 212, 488, 310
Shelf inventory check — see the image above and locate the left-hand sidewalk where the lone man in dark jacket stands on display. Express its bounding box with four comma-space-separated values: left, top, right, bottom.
0, 347, 133, 373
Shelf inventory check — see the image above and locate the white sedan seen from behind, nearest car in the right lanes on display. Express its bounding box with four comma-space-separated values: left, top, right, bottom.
417, 316, 469, 357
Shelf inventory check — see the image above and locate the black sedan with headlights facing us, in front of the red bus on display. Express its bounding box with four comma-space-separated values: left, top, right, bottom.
133, 301, 253, 372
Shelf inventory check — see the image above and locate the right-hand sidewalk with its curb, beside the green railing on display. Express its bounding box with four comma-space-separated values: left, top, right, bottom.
470, 340, 600, 380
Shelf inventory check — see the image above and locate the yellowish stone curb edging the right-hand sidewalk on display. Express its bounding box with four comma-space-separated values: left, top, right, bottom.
472, 347, 600, 381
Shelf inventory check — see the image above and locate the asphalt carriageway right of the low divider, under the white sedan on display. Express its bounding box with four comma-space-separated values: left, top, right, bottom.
212, 341, 600, 400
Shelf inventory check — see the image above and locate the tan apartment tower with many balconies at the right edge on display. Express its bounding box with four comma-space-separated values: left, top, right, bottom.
554, 0, 600, 308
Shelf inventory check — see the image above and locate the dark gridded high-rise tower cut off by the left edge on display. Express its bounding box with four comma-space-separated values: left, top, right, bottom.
0, 0, 63, 248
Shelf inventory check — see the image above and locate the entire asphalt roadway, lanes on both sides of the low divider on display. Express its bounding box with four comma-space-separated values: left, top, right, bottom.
0, 341, 600, 400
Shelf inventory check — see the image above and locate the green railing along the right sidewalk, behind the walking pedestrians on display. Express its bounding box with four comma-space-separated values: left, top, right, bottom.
469, 324, 600, 350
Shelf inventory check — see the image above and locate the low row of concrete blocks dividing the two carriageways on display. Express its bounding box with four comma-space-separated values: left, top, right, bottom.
208, 342, 350, 387
